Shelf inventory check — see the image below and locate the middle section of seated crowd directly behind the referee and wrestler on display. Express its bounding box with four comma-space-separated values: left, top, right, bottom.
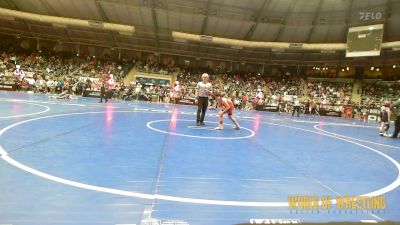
178, 70, 304, 110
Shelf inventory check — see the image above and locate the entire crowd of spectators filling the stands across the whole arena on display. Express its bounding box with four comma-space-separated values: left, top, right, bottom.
0, 45, 400, 119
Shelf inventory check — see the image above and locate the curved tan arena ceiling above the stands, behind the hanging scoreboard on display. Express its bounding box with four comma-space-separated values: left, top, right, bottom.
0, 0, 400, 64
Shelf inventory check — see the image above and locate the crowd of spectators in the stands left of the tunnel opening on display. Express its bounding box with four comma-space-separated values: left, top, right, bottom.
0, 48, 132, 95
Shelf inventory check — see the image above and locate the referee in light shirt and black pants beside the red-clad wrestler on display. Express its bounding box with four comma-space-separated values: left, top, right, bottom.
195, 73, 212, 126
